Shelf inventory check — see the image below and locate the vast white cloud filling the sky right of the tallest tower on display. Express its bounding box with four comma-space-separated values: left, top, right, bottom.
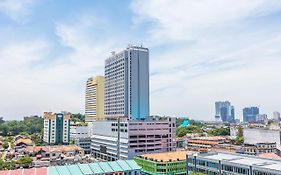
131, 0, 281, 120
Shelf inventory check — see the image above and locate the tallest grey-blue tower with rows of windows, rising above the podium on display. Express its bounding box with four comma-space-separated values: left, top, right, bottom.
105, 46, 149, 119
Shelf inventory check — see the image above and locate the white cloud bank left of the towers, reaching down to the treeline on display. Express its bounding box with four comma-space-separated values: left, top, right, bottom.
0, 15, 125, 119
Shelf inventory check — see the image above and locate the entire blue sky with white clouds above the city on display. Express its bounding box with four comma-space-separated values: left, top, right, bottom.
0, 0, 281, 120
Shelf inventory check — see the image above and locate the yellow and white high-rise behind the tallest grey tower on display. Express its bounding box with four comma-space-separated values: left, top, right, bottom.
85, 76, 104, 122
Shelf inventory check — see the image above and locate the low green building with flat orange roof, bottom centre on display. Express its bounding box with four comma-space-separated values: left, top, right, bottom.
134, 151, 191, 175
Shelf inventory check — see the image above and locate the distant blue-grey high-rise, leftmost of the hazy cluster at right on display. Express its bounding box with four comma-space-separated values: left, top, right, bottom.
215, 101, 235, 122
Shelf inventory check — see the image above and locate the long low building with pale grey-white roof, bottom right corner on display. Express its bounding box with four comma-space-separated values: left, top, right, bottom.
186, 153, 281, 175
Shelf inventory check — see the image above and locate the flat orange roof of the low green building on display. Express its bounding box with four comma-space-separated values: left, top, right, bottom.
137, 151, 193, 162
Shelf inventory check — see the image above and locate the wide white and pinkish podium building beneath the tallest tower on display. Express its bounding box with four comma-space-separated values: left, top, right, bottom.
91, 118, 176, 160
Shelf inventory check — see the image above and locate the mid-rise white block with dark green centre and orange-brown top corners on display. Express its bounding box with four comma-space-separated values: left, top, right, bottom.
43, 112, 71, 145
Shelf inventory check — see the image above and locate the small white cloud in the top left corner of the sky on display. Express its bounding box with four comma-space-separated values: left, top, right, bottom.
0, 0, 36, 22
